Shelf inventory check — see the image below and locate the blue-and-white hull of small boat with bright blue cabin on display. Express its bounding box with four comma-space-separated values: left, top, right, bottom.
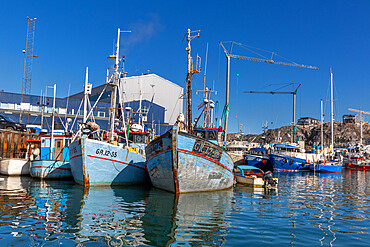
30, 160, 72, 179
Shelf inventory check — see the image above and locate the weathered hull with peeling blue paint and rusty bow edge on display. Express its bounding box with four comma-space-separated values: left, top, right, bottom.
146, 126, 234, 193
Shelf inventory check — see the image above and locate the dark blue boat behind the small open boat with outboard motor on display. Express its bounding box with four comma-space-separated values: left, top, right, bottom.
244, 148, 274, 172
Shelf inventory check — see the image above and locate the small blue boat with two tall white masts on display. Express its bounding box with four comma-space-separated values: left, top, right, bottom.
309, 70, 342, 173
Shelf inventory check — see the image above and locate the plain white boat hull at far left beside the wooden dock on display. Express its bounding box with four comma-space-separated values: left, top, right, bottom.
0, 159, 30, 176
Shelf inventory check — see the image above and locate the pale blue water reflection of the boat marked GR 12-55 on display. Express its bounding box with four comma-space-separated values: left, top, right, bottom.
71, 186, 148, 246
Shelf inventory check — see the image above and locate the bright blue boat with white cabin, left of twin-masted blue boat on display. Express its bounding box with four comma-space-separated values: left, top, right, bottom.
269, 143, 318, 171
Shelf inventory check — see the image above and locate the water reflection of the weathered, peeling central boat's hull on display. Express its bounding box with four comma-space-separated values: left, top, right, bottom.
143, 189, 233, 246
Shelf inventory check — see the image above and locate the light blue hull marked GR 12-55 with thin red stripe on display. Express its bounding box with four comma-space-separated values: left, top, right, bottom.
69, 138, 149, 186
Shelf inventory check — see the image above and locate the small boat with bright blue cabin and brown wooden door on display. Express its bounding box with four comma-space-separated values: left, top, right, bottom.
30, 133, 72, 179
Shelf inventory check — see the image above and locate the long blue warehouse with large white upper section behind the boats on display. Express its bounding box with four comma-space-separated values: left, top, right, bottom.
0, 74, 183, 135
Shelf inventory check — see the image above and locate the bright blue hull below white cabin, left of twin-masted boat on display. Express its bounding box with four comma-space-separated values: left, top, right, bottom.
270, 154, 310, 172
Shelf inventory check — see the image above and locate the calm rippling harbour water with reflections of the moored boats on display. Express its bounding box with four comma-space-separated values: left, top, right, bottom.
0, 170, 370, 246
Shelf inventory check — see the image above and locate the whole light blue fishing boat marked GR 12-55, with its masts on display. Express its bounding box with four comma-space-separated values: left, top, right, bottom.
69, 29, 149, 186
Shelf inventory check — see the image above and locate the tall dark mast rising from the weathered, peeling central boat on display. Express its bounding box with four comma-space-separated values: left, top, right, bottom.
185, 28, 200, 133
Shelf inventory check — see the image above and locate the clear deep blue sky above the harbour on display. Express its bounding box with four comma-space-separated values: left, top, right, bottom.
0, 0, 370, 133
